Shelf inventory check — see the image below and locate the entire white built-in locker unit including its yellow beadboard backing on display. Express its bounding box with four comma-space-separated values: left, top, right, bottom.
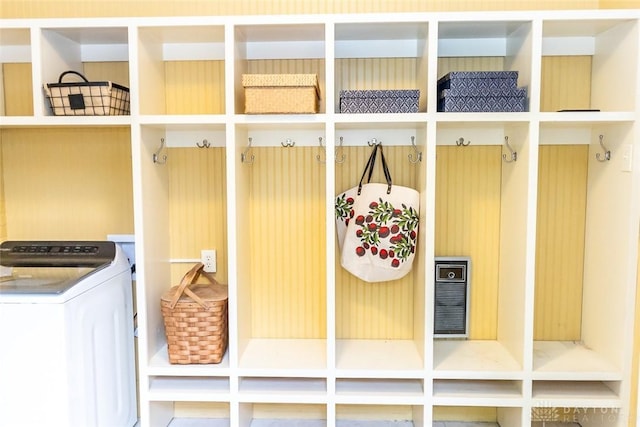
0, 4, 640, 427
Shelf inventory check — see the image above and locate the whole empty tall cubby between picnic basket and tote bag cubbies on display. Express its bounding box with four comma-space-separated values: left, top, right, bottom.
229, 120, 327, 375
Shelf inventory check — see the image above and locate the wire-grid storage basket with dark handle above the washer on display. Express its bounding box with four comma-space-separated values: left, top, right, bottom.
44, 71, 130, 116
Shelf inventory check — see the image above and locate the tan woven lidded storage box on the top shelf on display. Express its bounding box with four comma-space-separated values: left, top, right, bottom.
242, 74, 320, 114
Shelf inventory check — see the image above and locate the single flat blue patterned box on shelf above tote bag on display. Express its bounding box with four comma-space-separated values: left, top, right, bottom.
340, 89, 420, 114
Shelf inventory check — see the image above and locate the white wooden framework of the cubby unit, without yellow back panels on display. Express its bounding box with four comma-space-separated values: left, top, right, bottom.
0, 10, 640, 427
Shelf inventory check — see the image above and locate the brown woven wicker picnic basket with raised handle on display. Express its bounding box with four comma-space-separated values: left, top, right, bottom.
160, 263, 228, 365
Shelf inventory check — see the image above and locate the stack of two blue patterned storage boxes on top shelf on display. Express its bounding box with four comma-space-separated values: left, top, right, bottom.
438, 71, 527, 112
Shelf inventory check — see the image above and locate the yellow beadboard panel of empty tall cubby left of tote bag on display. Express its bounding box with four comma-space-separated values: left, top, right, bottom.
245, 147, 327, 338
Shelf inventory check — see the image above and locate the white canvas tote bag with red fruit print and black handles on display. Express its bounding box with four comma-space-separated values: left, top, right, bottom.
336, 143, 420, 282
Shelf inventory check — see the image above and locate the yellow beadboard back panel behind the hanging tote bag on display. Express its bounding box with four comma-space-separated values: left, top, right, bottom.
335, 146, 419, 339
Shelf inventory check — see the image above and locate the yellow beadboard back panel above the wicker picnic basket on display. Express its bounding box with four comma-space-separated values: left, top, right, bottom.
166, 147, 228, 284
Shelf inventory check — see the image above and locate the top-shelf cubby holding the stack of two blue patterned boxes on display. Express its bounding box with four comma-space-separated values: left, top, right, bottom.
430, 20, 535, 112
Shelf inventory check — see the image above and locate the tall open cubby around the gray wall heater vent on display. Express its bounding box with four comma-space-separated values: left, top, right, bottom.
434, 121, 534, 378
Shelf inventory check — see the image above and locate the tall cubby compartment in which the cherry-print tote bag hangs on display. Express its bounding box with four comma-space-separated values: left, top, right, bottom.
334, 121, 429, 377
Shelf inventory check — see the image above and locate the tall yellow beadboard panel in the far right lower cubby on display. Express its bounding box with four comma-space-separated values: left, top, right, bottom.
534, 145, 589, 341
